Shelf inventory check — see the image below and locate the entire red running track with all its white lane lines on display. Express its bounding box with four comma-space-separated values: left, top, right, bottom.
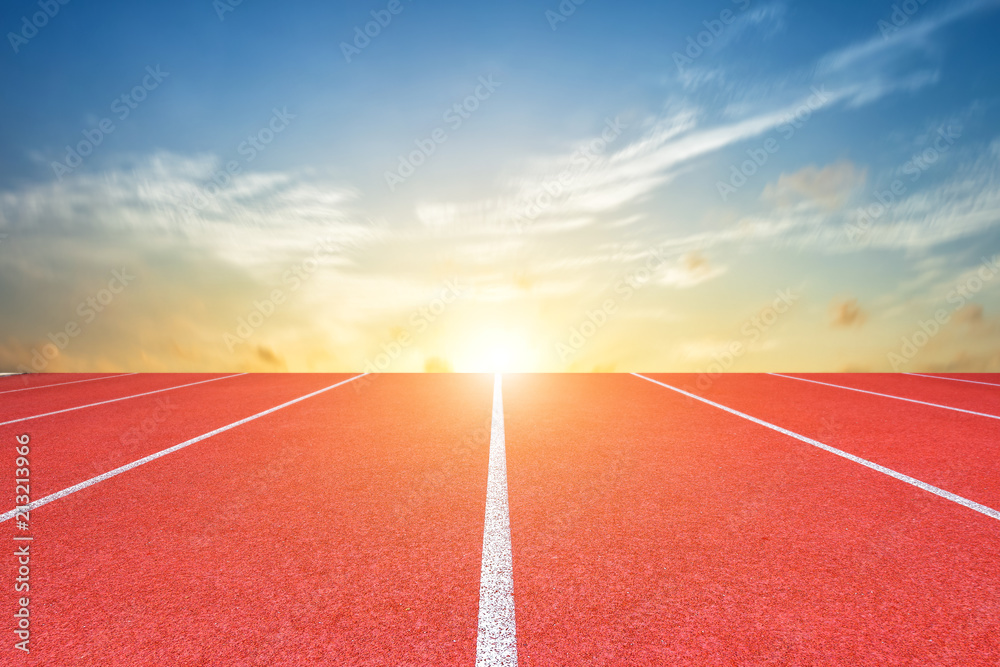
0, 374, 1000, 666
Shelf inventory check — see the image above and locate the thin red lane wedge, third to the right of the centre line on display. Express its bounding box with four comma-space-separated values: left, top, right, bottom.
786, 373, 1000, 423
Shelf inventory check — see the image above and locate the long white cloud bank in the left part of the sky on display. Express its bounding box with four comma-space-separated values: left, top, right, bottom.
0, 153, 377, 262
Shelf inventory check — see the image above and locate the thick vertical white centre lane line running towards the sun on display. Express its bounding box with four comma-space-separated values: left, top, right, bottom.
476, 373, 517, 667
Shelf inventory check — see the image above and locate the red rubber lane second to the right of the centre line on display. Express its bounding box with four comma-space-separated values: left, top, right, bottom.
650, 374, 1000, 510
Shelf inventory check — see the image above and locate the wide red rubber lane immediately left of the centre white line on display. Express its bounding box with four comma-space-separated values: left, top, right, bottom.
3, 376, 492, 666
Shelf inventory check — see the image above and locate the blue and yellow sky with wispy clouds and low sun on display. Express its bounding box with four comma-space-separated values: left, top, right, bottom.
0, 0, 1000, 376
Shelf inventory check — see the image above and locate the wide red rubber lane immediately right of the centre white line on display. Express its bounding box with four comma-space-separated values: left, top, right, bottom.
504, 376, 1000, 666
